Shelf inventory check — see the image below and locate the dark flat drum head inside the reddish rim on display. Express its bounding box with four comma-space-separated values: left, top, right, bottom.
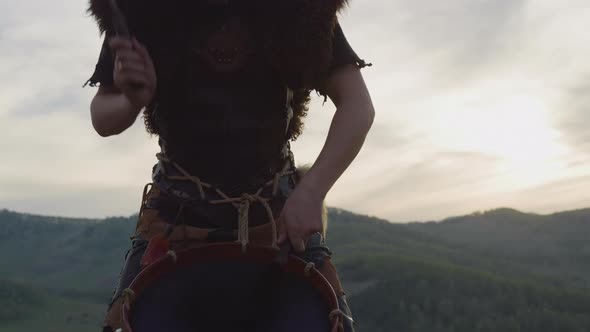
128, 244, 331, 332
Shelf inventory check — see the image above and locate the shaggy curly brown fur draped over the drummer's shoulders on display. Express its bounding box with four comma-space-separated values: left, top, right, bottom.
88, 0, 348, 139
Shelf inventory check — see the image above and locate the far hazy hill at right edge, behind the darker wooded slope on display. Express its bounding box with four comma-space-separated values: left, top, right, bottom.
407, 209, 590, 288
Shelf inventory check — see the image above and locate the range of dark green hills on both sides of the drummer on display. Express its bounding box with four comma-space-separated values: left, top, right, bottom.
0, 209, 590, 332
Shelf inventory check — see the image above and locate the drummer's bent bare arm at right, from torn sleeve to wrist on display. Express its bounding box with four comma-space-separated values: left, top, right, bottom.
300, 65, 375, 197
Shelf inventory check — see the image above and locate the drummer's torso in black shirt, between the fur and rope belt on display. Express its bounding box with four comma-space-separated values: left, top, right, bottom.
132, 4, 296, 188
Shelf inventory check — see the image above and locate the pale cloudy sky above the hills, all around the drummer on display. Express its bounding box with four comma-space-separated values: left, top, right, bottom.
0, 0, 590, 222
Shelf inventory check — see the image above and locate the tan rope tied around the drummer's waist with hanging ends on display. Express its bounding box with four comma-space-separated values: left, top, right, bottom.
156, 151, 295, 251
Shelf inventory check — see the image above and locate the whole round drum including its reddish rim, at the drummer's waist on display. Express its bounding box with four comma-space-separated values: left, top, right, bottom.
122, 243, 342, 332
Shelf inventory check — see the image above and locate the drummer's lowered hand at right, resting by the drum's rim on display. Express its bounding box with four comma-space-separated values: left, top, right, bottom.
277, 185, 324, 253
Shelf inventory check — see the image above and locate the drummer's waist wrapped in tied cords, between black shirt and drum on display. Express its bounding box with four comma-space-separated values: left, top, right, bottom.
147, 155, 297, 229
